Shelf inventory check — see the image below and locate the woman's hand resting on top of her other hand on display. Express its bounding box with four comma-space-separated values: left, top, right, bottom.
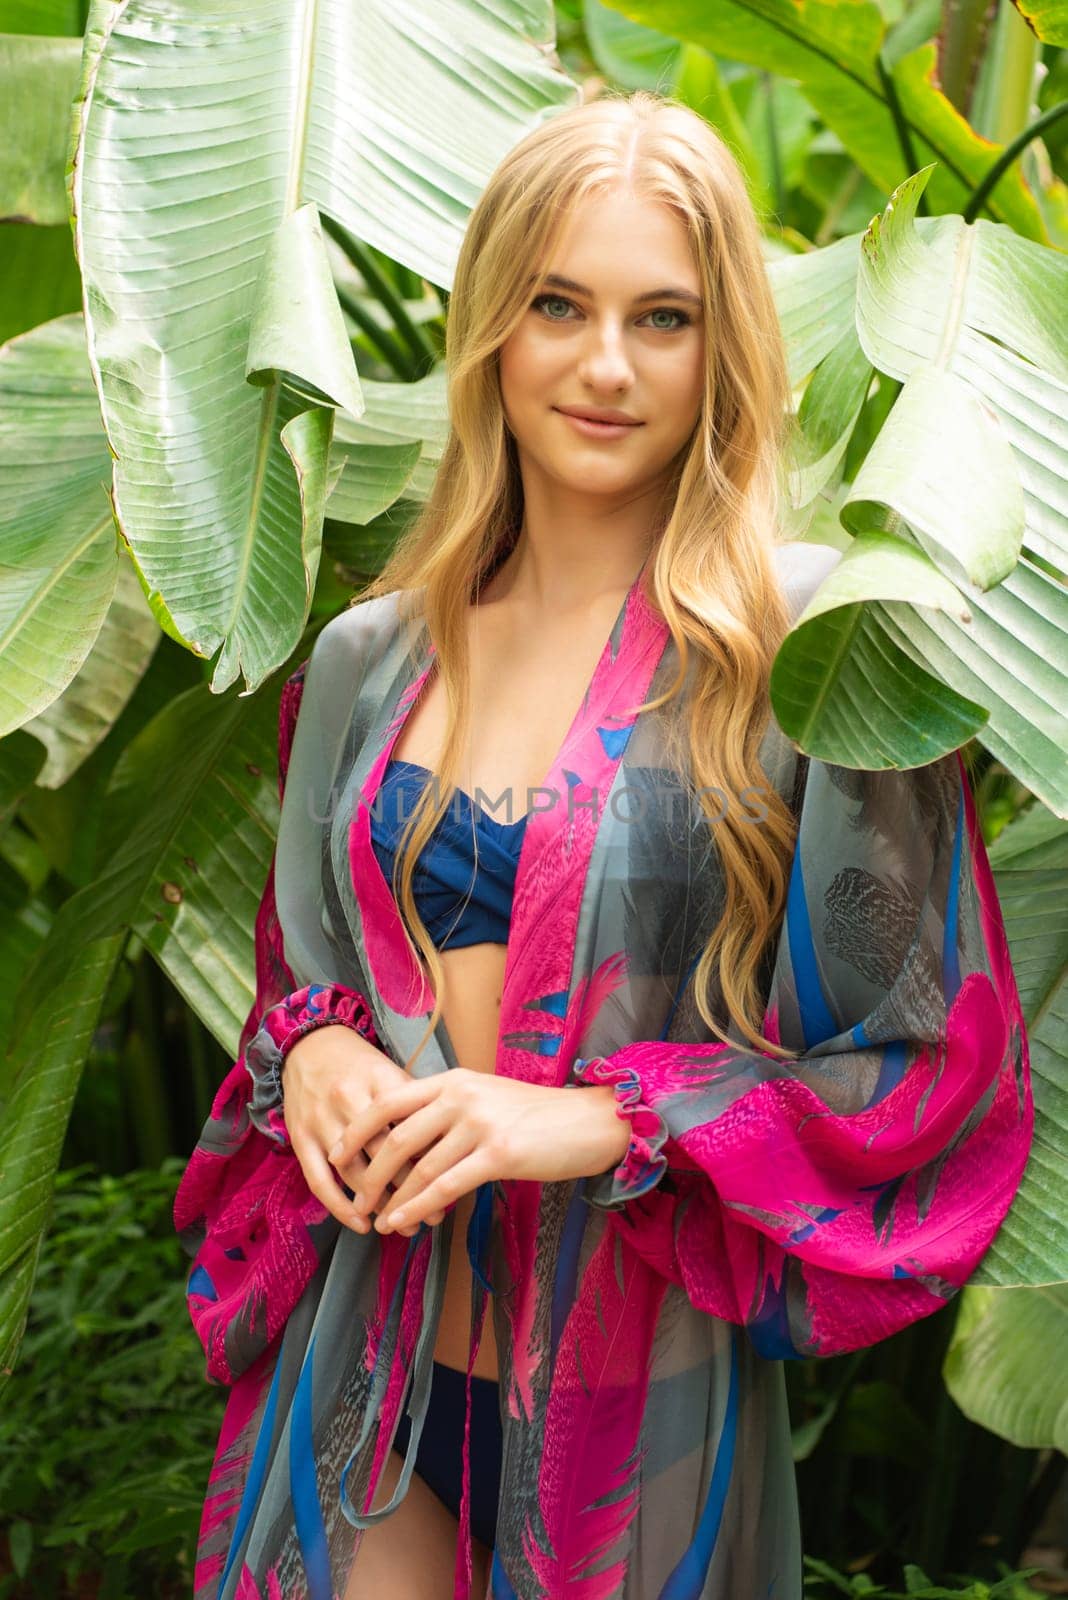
329, 1067, 630, 1234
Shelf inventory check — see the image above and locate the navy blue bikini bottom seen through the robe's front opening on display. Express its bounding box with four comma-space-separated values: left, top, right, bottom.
393, 1362, 504, 1550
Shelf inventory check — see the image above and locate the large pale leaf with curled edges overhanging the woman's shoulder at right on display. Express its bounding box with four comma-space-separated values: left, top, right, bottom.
772, 171, 1068, 814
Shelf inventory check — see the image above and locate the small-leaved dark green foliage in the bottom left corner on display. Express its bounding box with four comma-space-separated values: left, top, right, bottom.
0, 1160, 224, 1600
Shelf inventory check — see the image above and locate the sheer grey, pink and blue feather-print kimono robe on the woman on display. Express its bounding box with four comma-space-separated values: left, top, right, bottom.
176, 546, 1033, 1600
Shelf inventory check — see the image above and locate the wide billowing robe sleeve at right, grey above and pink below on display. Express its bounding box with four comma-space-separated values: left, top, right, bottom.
569, 754, 1033, 1358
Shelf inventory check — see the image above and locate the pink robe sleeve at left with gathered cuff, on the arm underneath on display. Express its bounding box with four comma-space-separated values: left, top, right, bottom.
174, 662, 377, 1384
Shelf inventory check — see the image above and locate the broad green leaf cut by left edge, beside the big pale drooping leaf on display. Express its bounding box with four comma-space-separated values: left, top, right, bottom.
0, 317, 118, 734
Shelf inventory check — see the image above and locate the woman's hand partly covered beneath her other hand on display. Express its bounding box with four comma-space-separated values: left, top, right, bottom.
281, 1022, 444, 1237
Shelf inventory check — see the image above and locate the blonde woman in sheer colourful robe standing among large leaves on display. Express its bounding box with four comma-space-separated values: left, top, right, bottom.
176, 93, 1033, 1600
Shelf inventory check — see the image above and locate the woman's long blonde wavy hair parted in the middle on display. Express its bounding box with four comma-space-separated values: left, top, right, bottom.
352, 91, 796, 1059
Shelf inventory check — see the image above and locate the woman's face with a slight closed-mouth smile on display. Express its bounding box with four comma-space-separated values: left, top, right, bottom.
500, 189, 705, 512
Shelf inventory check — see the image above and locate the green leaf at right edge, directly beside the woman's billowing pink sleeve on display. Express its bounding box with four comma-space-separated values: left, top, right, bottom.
972, 805, 1068, 1288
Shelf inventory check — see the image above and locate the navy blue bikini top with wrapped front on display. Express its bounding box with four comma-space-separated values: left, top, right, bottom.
371, 760, 526, 950
